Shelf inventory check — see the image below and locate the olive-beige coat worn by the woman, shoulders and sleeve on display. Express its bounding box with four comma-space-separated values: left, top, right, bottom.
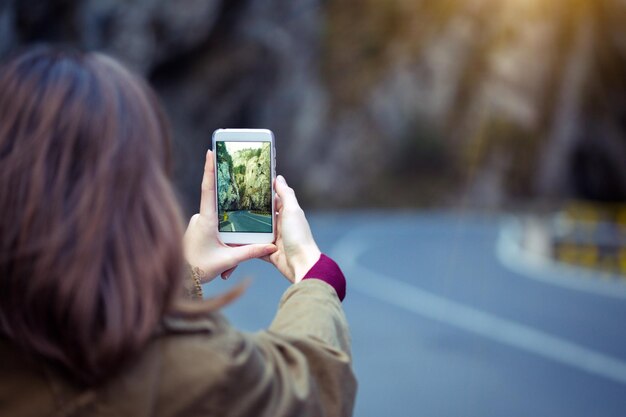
0, 280, 356, 417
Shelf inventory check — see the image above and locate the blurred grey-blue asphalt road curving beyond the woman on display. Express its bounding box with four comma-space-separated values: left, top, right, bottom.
205, 212, 626, 417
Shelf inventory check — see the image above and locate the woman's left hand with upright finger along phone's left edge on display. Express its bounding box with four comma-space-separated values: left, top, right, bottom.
183, 151, 276, 282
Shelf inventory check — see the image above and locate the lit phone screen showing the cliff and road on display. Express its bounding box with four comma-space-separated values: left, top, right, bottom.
216, 141, 273, 233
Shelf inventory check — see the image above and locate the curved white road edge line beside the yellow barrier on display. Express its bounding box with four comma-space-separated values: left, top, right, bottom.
496, 220, 626, 299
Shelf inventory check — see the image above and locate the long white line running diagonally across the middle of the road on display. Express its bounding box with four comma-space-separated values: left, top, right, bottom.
331, 228, 626, 384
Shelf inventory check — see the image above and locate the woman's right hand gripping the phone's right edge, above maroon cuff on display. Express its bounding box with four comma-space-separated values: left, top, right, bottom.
264, 175, 321, 283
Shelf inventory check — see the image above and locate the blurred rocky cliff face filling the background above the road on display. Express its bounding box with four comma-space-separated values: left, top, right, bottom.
0, 0, 626, 212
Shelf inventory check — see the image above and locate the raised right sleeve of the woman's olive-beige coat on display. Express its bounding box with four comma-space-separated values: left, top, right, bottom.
213, 280, 356, 417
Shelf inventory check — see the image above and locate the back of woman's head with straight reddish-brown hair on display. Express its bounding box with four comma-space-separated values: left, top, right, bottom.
0, 47, 183, 383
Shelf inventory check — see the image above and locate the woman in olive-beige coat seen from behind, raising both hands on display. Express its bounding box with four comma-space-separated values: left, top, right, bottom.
0, 47, 356, 416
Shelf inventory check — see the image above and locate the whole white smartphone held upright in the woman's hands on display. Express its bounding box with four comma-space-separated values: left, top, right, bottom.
213, 129, 276, 244
